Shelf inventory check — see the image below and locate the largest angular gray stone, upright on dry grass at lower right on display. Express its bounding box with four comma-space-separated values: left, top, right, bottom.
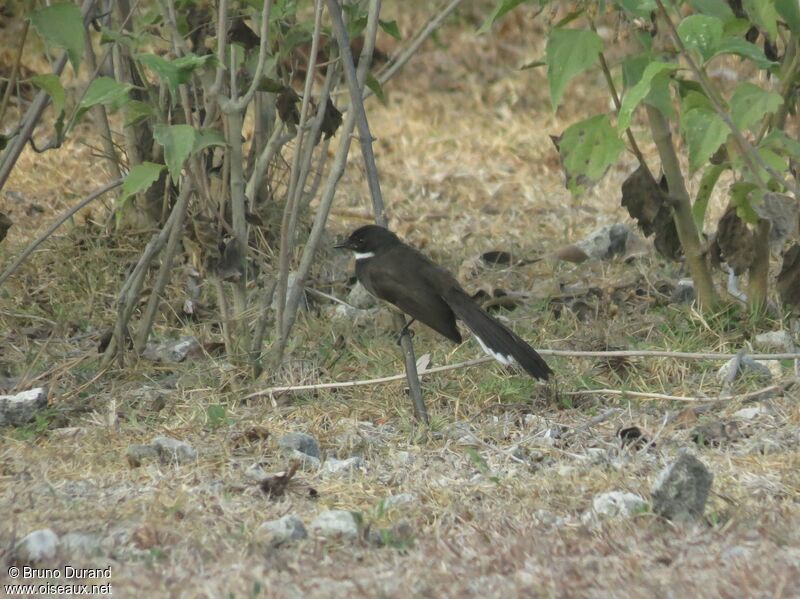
651, 453, 714, 520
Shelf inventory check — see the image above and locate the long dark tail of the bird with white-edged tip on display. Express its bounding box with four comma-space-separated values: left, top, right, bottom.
444, 289, 553, 380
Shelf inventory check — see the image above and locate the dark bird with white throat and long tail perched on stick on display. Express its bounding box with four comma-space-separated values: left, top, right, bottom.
334, 225, 553, 380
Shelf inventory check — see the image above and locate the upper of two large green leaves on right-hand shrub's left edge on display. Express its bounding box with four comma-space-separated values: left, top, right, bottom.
546, 29, 603, 110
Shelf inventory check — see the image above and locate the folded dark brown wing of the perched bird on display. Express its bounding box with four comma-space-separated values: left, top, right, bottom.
360, 255, 461, 343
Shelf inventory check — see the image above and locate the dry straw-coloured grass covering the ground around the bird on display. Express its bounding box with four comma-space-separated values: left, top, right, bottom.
0, 4, 800, 597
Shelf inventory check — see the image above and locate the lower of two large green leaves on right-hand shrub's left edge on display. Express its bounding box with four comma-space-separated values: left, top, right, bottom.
559, 114, 625, 195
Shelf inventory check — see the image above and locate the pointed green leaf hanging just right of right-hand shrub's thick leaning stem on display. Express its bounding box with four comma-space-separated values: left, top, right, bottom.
681, 92, 730, 173
